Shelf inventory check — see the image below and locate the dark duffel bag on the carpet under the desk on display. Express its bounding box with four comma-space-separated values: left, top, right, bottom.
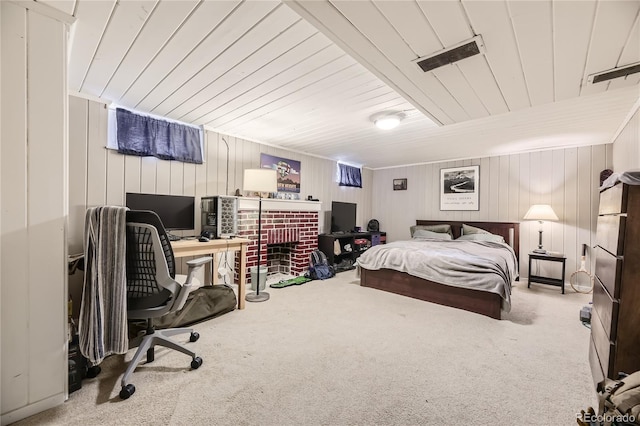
153, 284, 238, 329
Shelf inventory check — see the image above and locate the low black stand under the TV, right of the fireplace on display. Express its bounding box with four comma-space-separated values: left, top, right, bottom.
318, 232, 387, 272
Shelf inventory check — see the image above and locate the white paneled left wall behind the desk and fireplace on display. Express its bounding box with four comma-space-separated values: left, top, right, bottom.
68, 96, 373, 300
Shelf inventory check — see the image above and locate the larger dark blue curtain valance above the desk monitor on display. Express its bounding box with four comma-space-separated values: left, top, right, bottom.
116, 108, 202, 164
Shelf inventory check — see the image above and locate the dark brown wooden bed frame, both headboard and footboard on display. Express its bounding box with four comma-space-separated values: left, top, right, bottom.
360, 220, 520, 319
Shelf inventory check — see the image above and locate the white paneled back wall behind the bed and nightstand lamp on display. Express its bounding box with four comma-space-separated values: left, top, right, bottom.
372, 144, 612, 279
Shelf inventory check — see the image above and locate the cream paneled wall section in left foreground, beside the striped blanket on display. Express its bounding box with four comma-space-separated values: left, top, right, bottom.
0, 1, 68, 424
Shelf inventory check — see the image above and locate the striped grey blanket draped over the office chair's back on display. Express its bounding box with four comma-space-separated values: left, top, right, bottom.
79, 206, 129, 365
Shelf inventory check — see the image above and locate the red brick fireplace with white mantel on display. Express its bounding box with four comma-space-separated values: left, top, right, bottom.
236, 197, 320, 282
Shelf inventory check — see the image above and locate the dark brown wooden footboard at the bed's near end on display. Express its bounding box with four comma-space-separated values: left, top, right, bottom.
360, 268, 502, 319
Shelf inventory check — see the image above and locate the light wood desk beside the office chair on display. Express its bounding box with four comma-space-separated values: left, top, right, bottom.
171, 238, 250, 309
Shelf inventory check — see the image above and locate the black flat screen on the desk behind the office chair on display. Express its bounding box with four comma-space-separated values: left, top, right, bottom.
125, 192, 196, 231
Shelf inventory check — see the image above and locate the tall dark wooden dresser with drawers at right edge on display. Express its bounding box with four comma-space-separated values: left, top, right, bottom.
589, 183, 640, 386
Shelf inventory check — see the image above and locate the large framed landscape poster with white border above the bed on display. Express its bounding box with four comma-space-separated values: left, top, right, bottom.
440, 166, 480, 210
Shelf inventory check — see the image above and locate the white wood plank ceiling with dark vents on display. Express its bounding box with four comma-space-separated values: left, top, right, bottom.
40, 0, 640, 168
